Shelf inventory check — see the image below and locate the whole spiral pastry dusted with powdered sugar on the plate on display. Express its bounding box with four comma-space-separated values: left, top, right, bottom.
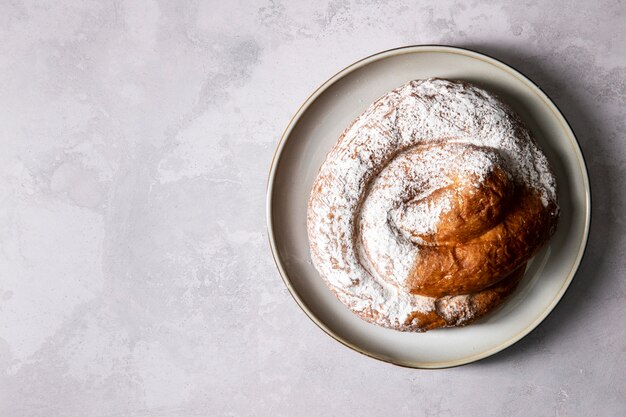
307, 79, 559, 331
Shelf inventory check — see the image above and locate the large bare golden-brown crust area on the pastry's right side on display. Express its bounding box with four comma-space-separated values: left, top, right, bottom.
406, 165, 557, 297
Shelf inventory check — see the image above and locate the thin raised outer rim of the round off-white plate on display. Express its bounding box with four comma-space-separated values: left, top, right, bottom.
266, 44, 592, 369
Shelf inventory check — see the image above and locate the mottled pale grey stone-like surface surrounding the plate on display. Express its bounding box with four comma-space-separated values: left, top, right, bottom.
0, 0, 626, 417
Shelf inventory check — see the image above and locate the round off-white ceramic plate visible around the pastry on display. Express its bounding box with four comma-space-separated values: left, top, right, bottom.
267, 46, 591, 368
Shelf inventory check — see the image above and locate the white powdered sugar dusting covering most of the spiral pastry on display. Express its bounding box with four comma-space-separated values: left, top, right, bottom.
308, 79, 556, 330
